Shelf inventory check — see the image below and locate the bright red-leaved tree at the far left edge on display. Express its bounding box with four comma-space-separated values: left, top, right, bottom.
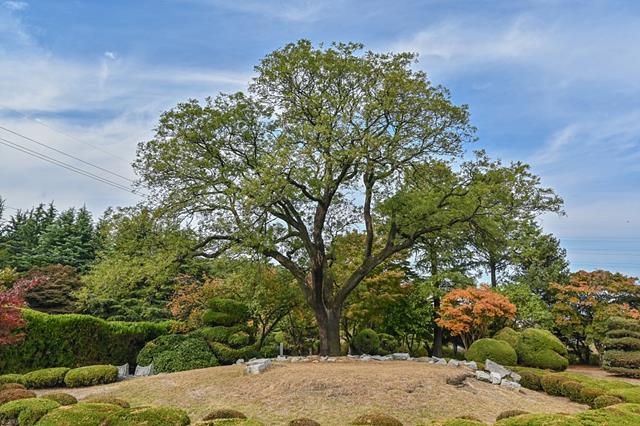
0, 278, 42, 346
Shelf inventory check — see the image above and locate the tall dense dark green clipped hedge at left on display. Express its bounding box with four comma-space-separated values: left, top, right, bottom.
0, 310, 170, 374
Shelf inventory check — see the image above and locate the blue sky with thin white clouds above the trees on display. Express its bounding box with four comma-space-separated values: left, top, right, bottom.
0, 0, 640, 276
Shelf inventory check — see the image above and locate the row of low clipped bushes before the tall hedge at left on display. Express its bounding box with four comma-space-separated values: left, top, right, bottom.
0, 365, 118, 392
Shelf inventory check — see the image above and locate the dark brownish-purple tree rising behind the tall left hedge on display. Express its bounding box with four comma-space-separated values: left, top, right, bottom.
25, 265, 82, 314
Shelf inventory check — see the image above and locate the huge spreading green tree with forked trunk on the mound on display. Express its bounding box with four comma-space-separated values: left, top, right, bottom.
135, 41, 540, 355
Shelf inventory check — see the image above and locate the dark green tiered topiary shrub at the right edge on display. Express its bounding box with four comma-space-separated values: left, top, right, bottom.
602, 317, 640, 377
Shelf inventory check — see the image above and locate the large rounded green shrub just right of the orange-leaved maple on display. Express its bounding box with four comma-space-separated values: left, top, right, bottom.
516, 328, 569, 371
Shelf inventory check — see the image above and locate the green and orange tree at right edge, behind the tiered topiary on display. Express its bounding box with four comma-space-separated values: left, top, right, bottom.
551, 270, 640, 363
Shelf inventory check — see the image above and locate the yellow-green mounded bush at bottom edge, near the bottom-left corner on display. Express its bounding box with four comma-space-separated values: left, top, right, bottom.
38, 403, 124, 426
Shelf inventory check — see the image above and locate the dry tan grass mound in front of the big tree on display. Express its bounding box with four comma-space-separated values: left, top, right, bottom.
36, 360, 587, 426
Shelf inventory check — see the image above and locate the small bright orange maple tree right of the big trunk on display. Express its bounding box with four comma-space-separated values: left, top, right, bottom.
436, 285, 516, 349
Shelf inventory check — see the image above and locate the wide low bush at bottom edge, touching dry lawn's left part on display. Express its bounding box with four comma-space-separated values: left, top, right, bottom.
106, 407, 191, 426
